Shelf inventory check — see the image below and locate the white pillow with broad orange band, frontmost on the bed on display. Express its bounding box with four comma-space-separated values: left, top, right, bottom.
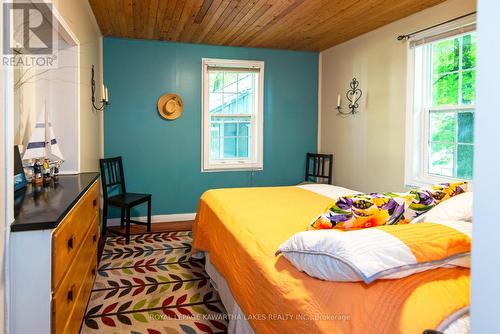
276, 221, 472, 284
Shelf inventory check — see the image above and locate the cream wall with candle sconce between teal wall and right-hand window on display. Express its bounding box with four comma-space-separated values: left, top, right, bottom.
319, 0, 476, 192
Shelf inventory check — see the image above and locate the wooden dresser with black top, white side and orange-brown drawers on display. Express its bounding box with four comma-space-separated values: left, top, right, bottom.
10, 173, 100, 334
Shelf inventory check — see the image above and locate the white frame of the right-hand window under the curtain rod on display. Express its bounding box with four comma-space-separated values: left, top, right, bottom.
405, 21, 476, 187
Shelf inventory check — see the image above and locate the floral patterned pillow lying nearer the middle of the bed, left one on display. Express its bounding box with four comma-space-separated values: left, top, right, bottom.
308, 193, 413, 230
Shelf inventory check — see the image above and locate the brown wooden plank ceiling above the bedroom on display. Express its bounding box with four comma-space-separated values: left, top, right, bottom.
89, 0, 444, 51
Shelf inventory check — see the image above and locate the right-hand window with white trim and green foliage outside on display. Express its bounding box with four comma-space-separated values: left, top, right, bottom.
406, 17, 476, 185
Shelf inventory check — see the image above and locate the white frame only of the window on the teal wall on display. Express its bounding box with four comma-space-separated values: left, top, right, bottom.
201, 58, 264, 172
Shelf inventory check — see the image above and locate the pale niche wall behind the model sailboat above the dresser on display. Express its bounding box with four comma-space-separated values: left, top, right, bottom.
14, 42, 80, 173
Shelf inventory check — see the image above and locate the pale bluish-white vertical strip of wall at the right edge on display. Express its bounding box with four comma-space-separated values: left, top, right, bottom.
471, 0, 500, 334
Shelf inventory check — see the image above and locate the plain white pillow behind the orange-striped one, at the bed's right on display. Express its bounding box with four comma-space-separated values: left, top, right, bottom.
410, 191, 472, 224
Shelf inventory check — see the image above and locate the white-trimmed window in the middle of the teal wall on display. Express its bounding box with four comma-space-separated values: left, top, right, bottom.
202, 59, 264, 171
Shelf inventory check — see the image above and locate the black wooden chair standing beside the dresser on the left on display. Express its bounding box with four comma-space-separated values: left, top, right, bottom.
99, 157, 151, 244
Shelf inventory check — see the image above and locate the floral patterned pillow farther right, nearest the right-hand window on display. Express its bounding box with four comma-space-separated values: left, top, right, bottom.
404, 182, 468, 221
